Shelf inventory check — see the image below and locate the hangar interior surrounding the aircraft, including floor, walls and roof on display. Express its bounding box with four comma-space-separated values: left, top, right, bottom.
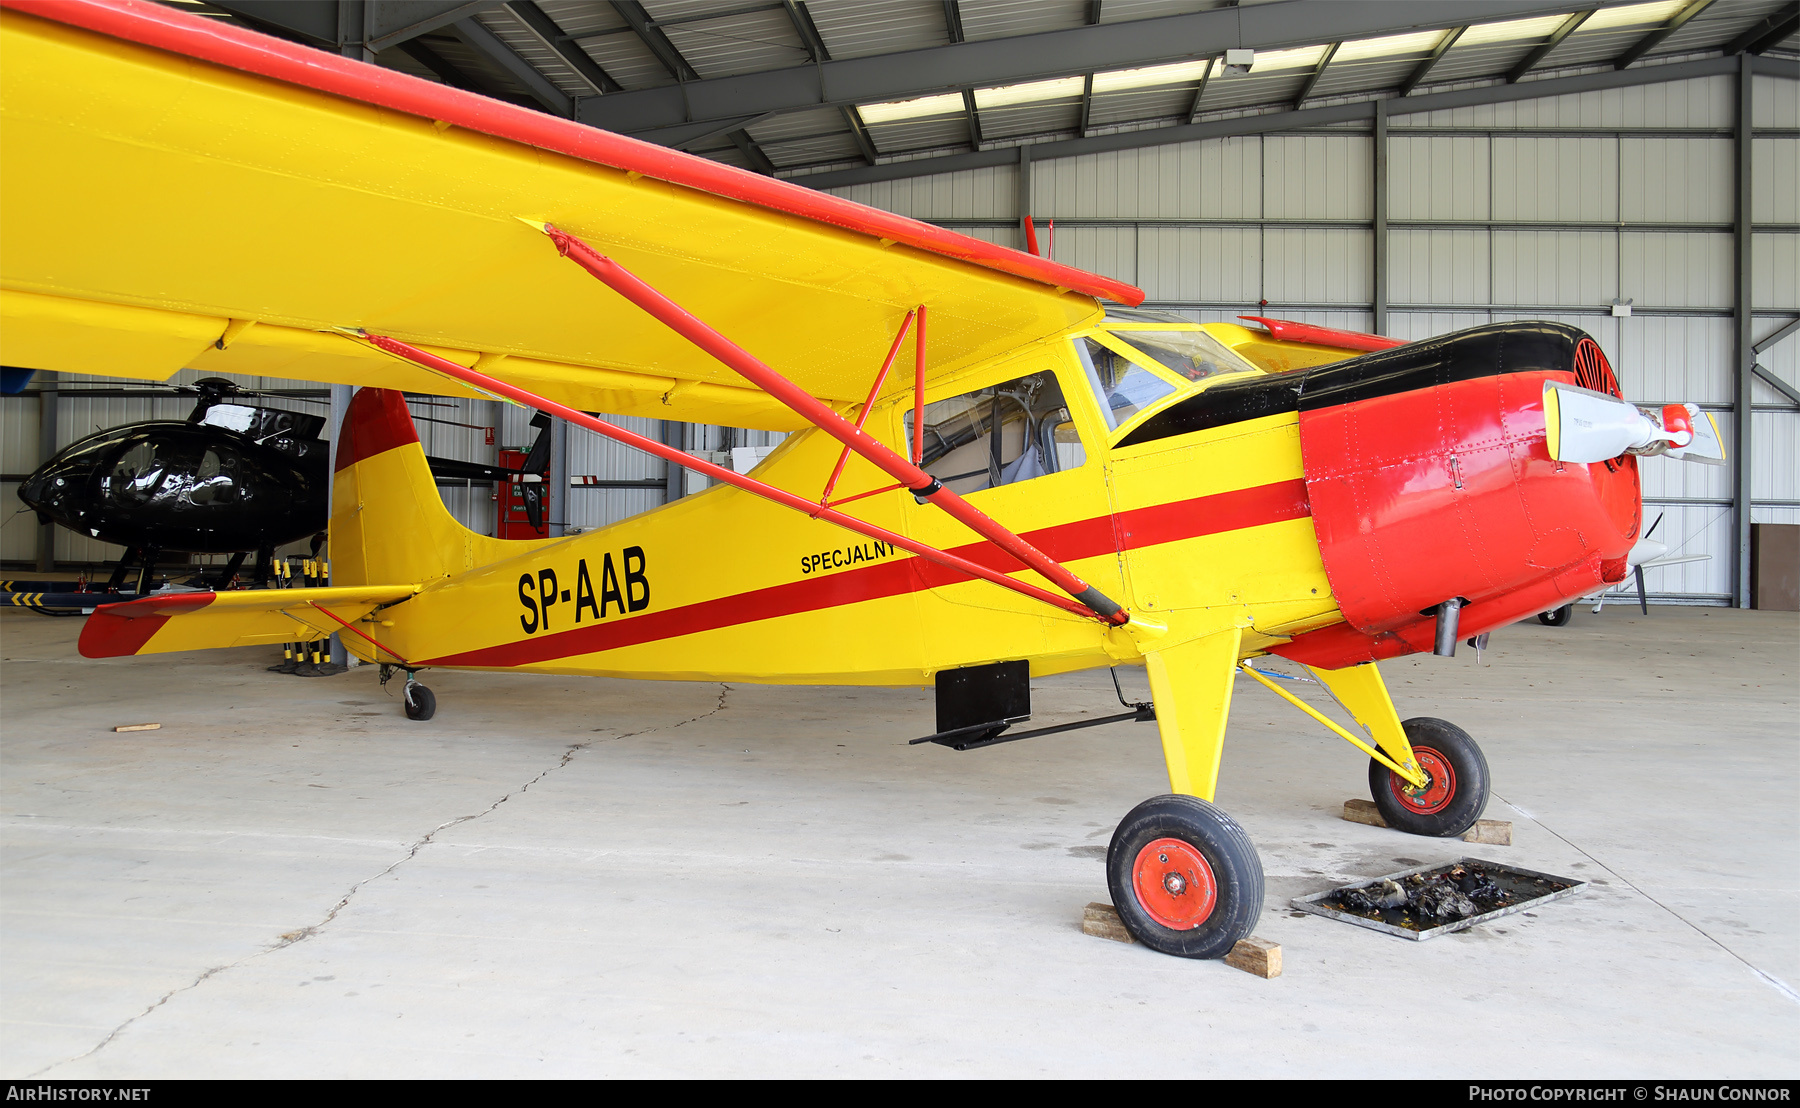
0, 0, 1800, 1079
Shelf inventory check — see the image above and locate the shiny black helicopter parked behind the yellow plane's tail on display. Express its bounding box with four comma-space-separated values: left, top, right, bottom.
18, 378, 549, 599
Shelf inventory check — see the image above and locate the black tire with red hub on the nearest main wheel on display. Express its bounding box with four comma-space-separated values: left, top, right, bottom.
1107, 795, 1262, 959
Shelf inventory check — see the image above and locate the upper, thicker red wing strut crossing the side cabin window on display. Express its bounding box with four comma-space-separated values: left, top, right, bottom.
524, 219, 1130, 626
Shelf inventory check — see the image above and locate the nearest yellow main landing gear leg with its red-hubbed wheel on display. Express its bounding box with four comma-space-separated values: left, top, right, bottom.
1107, 628, 1264, 959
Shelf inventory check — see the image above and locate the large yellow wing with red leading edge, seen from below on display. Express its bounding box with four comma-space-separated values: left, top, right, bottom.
0, 0, 1141, 430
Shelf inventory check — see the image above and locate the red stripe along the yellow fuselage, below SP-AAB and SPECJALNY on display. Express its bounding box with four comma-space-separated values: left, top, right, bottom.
418, 478, 1310, 667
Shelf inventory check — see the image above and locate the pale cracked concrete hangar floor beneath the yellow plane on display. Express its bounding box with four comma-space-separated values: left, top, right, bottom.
0, 608, 1800, 1079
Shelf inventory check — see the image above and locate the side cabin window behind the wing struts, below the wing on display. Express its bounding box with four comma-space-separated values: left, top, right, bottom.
905, 372, 1087, 495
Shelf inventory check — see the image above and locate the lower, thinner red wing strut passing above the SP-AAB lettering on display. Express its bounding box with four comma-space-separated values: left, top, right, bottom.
344, 327, 1096, 622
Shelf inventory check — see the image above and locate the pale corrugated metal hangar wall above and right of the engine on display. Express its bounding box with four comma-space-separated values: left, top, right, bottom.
833, 69, 1800, 603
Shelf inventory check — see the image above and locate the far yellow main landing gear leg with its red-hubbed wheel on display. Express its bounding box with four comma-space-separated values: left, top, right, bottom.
1307, 662, 1490, 836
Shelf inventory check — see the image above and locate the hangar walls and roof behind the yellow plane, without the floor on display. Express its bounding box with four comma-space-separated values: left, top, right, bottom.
0, 0, 1800, 606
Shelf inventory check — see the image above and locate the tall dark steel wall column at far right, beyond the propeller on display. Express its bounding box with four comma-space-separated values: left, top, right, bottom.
1732, 54, 1757, 608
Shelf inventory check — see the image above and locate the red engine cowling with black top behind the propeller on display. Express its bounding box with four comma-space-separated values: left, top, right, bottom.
1274, 324, 1643, 669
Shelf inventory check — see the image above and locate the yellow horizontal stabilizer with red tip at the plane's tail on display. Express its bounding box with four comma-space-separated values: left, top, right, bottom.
79, 585, 418, 658
